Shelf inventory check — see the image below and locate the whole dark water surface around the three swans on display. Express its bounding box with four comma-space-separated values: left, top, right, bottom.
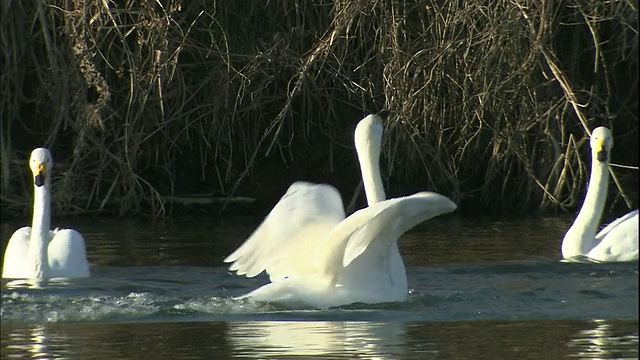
0, 216, 638, 359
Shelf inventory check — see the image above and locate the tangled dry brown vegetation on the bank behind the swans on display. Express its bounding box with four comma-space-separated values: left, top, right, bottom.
0, 0, 638, 218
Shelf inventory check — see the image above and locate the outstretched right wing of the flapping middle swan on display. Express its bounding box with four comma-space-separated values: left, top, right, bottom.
342, 192, 457, 267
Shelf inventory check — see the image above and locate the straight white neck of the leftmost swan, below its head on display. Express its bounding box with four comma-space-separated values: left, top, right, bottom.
28, 179, 51, 278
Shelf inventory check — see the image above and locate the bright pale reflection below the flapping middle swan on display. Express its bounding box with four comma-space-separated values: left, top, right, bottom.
227, 321, 406, 359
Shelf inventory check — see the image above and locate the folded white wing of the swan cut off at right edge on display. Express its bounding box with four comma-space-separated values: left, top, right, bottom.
587, 210, 639, 261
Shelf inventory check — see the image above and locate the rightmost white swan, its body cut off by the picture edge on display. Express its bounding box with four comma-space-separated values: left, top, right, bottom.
562, 127, 638, 262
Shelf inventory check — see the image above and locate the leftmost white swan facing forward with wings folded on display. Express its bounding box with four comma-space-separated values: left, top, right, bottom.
2, 148, 89, 279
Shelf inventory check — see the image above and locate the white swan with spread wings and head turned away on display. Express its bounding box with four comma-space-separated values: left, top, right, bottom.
224, 115, 456, 308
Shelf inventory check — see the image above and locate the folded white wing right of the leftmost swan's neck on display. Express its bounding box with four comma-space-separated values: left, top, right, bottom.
47, 229, 90, 278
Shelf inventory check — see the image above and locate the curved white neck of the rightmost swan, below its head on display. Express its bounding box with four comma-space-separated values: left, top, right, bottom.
562, 156, 609, 258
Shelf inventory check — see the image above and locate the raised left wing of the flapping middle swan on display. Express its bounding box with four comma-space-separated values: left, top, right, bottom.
224, 182, 345, 281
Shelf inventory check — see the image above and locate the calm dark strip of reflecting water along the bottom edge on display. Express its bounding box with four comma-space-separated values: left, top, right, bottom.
1, 319, 638, 359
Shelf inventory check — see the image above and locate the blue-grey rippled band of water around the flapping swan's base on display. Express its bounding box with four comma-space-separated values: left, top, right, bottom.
1, 260, 638, 323
